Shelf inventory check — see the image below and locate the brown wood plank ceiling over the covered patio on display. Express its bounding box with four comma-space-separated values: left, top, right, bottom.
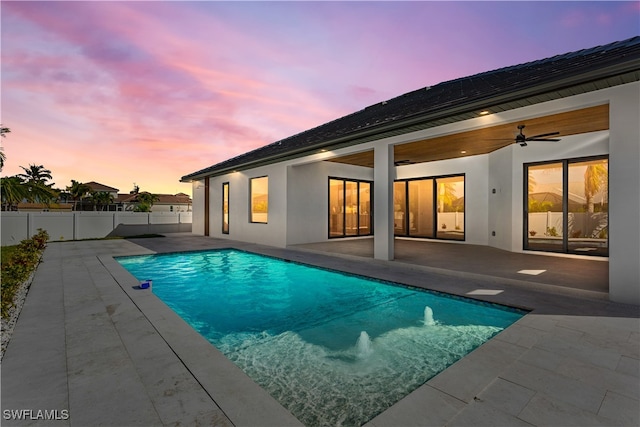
327, 104, 609, 168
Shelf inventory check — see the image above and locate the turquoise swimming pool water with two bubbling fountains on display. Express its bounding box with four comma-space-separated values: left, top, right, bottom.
117, 249, 524, 426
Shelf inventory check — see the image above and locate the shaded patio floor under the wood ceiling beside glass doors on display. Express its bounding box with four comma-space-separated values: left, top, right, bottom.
292, 237, 609, 299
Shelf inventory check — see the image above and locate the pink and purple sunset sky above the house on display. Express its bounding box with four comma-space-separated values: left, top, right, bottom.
0, 0, 640, 194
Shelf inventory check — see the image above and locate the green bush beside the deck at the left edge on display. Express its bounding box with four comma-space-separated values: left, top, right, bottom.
0, 229, 49, 318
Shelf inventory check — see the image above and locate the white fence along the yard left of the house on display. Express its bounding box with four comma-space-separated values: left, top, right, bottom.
0, 211, 192, 246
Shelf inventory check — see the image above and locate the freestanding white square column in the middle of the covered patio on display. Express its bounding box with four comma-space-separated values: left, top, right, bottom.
373, 145, 395, 261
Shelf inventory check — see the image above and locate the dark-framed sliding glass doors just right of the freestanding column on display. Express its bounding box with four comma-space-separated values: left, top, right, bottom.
393, 175, 465, 240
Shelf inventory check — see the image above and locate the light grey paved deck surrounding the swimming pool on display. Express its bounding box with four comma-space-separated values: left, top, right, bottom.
1, 234, 640, 427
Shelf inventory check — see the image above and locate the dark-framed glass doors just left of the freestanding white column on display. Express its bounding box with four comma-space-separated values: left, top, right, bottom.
329, 178, 373, 238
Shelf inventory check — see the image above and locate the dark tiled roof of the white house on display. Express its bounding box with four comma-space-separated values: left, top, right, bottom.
182, 36, 640, 181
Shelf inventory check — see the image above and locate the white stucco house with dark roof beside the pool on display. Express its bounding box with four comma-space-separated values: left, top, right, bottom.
182, 37, 640, 304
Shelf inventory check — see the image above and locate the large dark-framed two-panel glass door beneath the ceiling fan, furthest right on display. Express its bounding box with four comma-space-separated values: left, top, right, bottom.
524, 157, 609, 256
